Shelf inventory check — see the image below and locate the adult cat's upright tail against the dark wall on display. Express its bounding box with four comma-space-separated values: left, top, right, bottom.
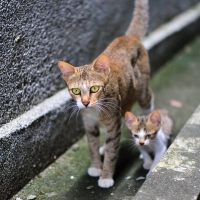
125, 0, 149, 39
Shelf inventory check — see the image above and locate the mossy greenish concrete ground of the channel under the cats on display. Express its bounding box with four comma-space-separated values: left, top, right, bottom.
12, 37, 200, 200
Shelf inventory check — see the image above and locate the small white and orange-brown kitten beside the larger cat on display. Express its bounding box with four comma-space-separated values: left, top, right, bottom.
125, 109, 173, 174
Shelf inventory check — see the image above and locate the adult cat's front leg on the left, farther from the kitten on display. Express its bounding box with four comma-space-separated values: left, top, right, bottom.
87, 127, 102, 177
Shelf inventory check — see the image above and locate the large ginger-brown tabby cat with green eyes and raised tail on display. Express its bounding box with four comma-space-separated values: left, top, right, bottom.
58, 0, 153, 188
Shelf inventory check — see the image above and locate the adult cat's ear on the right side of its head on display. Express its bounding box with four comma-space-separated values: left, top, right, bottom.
93, 54, 110, 76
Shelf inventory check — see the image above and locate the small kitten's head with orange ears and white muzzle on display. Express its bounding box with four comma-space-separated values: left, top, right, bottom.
125, 111, 161, 146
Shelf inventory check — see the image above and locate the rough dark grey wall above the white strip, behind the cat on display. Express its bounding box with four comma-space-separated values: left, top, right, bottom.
0, 0, 198, 126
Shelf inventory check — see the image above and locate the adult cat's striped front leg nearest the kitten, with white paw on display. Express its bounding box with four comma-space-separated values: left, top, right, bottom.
98, 116, 121, 188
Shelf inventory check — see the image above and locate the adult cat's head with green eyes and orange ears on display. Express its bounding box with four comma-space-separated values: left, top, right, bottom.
58, 54, 110, 109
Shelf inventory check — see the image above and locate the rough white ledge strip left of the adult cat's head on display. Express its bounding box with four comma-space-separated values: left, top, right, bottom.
0, 89, 71, 139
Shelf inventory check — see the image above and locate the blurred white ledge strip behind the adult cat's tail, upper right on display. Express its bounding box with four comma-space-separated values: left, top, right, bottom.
143, 3, 200, 51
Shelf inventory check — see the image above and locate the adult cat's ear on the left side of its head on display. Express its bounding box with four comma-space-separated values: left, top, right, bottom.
58, 61, 75, 82
